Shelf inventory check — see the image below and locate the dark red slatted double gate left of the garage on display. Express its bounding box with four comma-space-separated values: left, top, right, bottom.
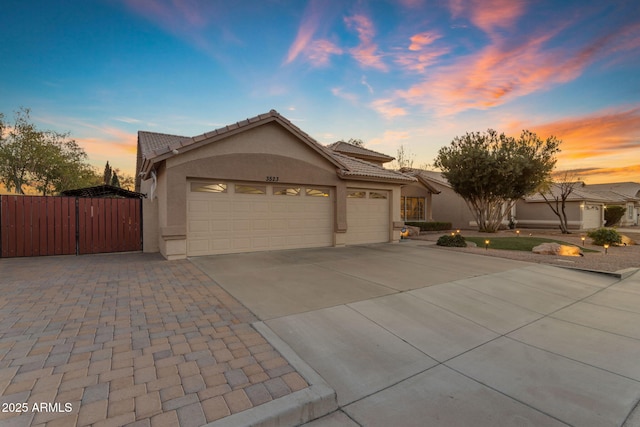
0, 195, 142, 258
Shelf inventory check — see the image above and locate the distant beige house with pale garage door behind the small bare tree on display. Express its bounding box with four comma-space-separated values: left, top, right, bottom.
516, 183, 610, 230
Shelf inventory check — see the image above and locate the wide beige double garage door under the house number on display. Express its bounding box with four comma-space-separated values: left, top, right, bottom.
187, 182, 333, 256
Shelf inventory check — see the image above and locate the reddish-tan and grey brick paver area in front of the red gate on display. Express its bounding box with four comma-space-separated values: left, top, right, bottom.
0, 253, 308, 427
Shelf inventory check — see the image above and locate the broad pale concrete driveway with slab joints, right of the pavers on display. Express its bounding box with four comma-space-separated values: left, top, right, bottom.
191, 242, 640, 427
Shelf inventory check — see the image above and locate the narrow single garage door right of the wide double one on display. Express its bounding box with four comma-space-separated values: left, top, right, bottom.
346, 189, 390, 245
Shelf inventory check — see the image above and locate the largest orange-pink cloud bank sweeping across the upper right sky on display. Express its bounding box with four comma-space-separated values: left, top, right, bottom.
384, 20, 640, 116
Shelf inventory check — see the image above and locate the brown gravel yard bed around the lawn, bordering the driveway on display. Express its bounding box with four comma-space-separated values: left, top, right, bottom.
412, 227, 640, 272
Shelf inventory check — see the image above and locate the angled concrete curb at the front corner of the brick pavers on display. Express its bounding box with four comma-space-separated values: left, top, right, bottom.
203, 322, 338, 427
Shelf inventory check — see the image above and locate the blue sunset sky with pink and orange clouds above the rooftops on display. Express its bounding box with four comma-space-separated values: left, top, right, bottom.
0, 0, 640, 184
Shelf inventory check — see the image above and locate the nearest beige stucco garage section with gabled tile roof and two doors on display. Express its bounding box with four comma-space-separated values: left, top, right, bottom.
136, 110, 416, 259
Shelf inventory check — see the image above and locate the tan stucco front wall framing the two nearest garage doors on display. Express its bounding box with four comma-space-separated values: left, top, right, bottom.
142, 122, 400, 259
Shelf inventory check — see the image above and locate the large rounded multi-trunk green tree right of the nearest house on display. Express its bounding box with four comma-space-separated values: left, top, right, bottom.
434, 129, 561, 232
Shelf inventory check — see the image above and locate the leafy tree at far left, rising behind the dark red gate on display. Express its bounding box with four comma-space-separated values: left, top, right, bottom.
0, 108, 99, 195
